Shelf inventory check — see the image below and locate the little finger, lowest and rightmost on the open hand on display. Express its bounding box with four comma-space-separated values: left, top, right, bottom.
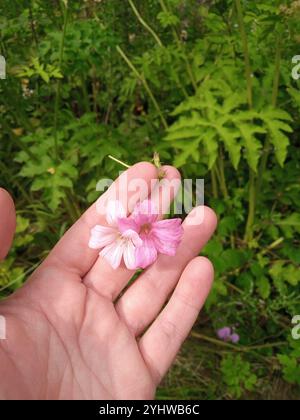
139, 257, 214, 384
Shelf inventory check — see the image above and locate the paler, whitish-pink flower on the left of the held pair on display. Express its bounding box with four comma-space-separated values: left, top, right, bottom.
89, 201, 142, 270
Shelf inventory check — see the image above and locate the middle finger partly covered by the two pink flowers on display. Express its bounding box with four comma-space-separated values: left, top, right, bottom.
84, 166, 180, 301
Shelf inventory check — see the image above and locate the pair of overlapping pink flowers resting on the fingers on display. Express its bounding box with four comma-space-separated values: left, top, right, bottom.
89, 200, 183, 270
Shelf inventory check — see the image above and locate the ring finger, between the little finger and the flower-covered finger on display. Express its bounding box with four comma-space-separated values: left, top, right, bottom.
116, 206, 217, 336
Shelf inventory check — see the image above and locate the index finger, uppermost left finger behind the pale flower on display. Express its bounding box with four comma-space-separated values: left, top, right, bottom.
42, 162, 157, 277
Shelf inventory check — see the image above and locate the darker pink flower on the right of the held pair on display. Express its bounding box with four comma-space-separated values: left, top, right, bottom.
118, 200, 183, 268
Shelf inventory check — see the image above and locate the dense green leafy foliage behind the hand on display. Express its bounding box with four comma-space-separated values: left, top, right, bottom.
0, 0, 300, 399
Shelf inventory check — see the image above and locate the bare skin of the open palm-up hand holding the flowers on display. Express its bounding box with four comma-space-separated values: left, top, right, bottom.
0, 163, 217, 400
